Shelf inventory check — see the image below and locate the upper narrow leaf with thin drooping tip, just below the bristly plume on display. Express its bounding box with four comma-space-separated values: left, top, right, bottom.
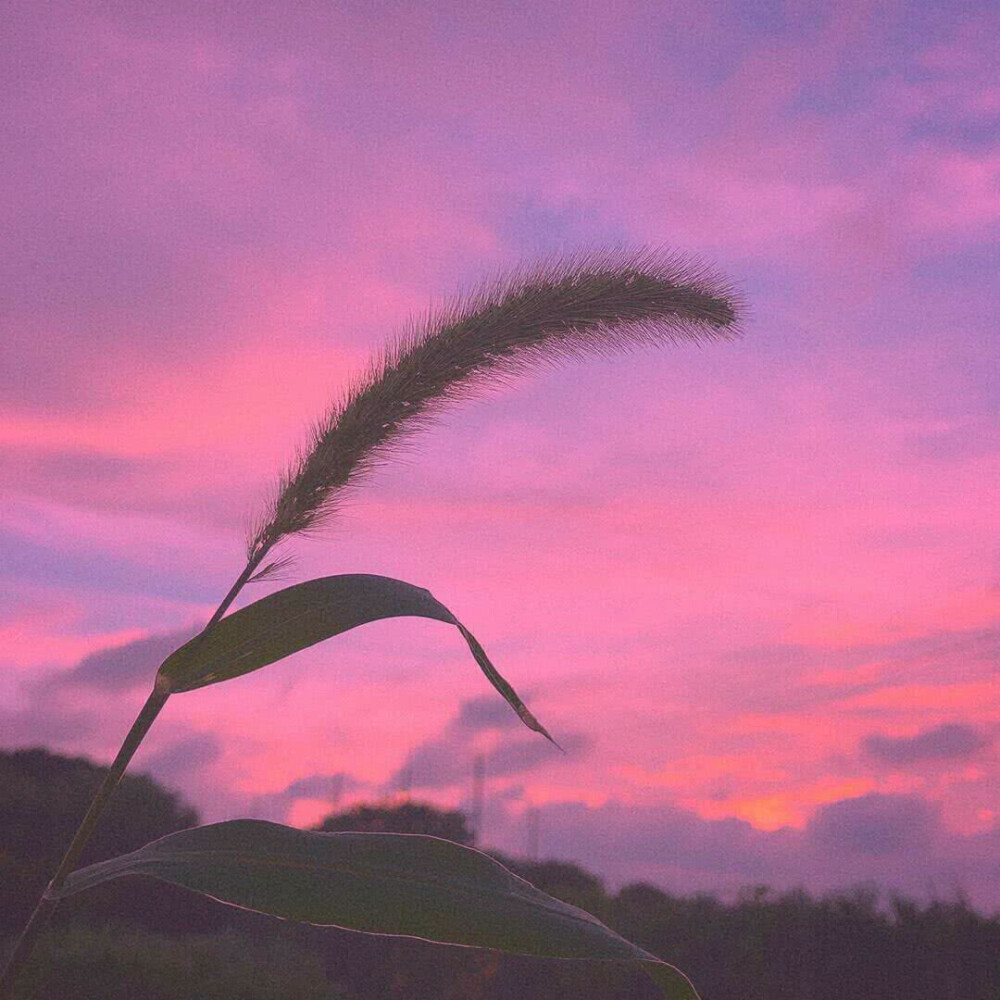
157, 573, 558, 745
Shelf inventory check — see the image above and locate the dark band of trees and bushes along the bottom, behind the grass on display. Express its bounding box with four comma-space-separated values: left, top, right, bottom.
0, 750, 1000, 1000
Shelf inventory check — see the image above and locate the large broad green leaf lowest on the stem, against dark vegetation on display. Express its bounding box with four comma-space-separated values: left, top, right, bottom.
55, 820, 698, 1000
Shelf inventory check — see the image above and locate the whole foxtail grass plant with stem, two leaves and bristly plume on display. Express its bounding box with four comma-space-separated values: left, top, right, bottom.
0, 250, 740, 1000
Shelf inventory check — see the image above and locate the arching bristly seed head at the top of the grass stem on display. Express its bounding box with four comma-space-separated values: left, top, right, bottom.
247, 250, 739, 572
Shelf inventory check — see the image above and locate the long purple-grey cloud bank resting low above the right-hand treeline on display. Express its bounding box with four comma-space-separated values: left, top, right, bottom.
508, 795, 1000, 910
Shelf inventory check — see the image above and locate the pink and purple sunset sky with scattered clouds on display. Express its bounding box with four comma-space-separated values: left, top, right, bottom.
0, 0, 1000, 910
